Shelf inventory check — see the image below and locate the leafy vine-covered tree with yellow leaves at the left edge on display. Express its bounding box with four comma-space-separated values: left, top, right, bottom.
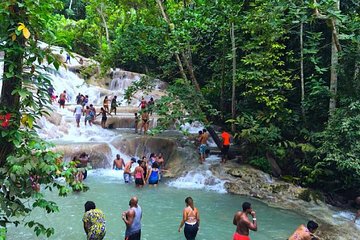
0, 0, 88, 236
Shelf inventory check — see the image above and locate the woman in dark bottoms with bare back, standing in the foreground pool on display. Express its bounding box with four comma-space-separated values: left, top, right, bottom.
178, 197, 200, 240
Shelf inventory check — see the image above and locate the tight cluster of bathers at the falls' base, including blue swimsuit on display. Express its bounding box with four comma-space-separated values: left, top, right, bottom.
113, 153, 165, 188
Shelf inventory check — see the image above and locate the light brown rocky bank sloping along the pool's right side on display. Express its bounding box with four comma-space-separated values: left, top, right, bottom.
211, 161, 360, 240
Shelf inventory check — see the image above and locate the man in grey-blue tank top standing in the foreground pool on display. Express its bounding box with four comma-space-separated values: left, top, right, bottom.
122, 197, 142, 240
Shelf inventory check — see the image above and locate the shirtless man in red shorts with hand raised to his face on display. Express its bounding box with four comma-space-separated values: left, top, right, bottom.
233, 202, 257, 240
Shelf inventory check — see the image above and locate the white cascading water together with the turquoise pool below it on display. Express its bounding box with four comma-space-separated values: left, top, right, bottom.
0, 48, 358, 240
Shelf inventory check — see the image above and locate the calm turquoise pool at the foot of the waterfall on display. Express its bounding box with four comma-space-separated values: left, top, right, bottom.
8, 170, 306, 240
